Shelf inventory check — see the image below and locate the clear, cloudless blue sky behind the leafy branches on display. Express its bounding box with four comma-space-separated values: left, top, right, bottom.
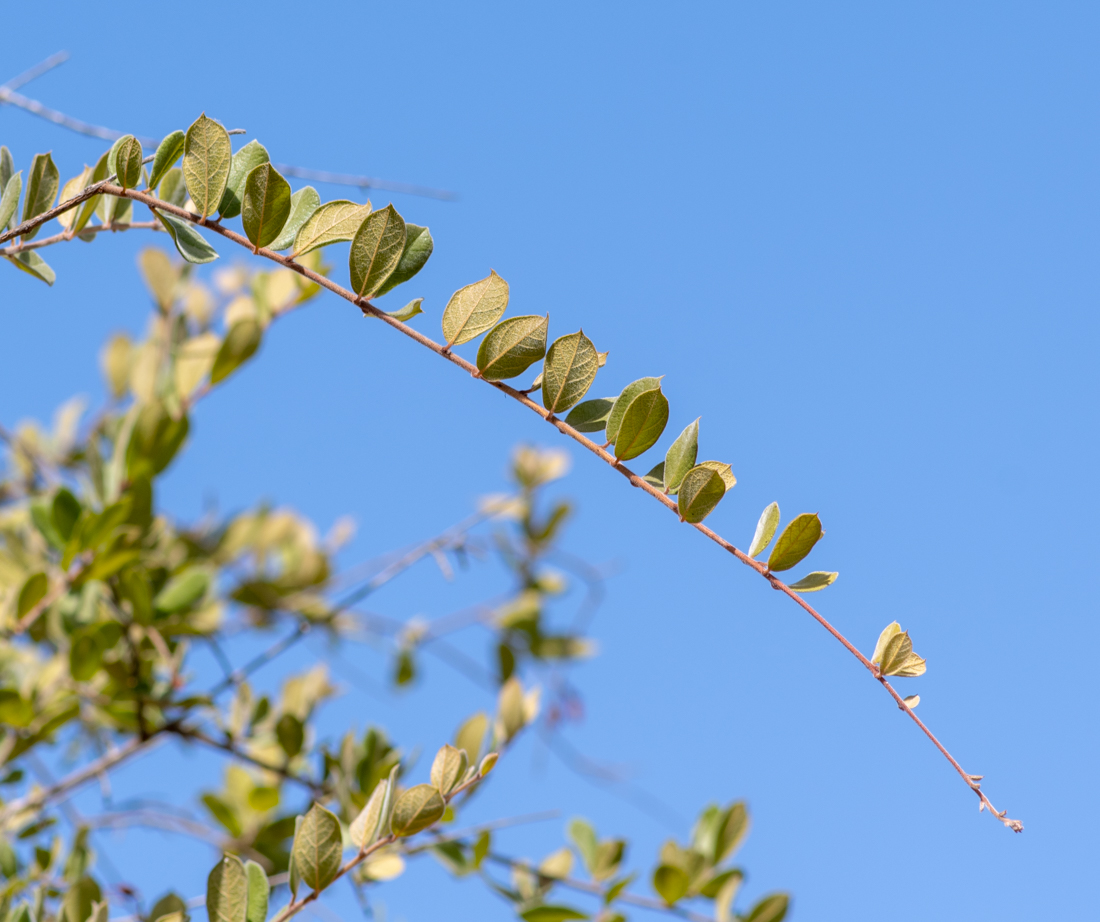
0, 0, 1100, 922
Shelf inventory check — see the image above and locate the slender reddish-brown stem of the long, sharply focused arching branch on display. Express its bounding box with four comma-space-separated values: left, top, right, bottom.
0, 185, 1023, 832
